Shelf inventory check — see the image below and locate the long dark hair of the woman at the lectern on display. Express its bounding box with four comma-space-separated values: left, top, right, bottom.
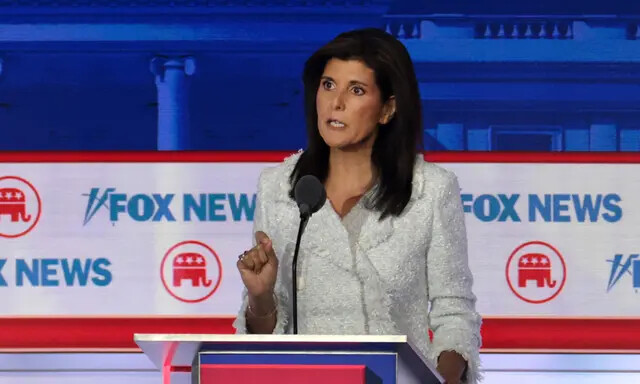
289, 28, 422, 220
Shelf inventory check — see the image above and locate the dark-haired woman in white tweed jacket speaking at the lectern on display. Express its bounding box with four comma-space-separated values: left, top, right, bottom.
234, 29, 480, 384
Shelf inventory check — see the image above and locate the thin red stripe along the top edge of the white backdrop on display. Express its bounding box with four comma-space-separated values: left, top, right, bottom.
0, 151, 640, 163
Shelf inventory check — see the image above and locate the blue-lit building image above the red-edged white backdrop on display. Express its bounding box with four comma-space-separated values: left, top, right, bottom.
0, 0, 640, 151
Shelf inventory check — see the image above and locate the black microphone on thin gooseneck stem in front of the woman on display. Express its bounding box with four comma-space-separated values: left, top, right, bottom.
291, 175, 327, 335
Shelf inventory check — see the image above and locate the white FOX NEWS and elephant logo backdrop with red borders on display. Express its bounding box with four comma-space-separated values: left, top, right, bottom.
0, 152, 640, 351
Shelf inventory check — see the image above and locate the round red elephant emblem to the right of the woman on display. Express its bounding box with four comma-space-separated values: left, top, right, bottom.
506, 241, 567, 304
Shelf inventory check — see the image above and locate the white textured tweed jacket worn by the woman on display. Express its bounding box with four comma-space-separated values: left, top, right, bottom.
234, 154, 481, 383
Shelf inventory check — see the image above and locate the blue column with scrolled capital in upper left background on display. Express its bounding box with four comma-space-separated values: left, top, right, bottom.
151, 57, 196, 151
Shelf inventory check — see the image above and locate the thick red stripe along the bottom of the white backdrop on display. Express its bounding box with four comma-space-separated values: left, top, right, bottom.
0, 317, 640, 352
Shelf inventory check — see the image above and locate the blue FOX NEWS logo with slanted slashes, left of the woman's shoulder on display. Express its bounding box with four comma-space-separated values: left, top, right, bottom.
83, 188, 256, 225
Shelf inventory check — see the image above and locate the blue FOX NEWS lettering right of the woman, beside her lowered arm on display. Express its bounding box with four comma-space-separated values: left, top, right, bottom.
461, 193, 622, 223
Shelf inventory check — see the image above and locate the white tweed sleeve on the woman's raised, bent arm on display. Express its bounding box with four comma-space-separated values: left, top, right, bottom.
233, 169, 289, 334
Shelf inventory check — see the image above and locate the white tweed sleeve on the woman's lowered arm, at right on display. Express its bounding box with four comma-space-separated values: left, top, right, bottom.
427, 171, 481, 384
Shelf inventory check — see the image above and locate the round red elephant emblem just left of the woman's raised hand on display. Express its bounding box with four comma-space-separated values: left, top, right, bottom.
160, 240, 222, 303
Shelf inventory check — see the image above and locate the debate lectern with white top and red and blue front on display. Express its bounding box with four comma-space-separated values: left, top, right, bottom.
134, 334, 444, 384
